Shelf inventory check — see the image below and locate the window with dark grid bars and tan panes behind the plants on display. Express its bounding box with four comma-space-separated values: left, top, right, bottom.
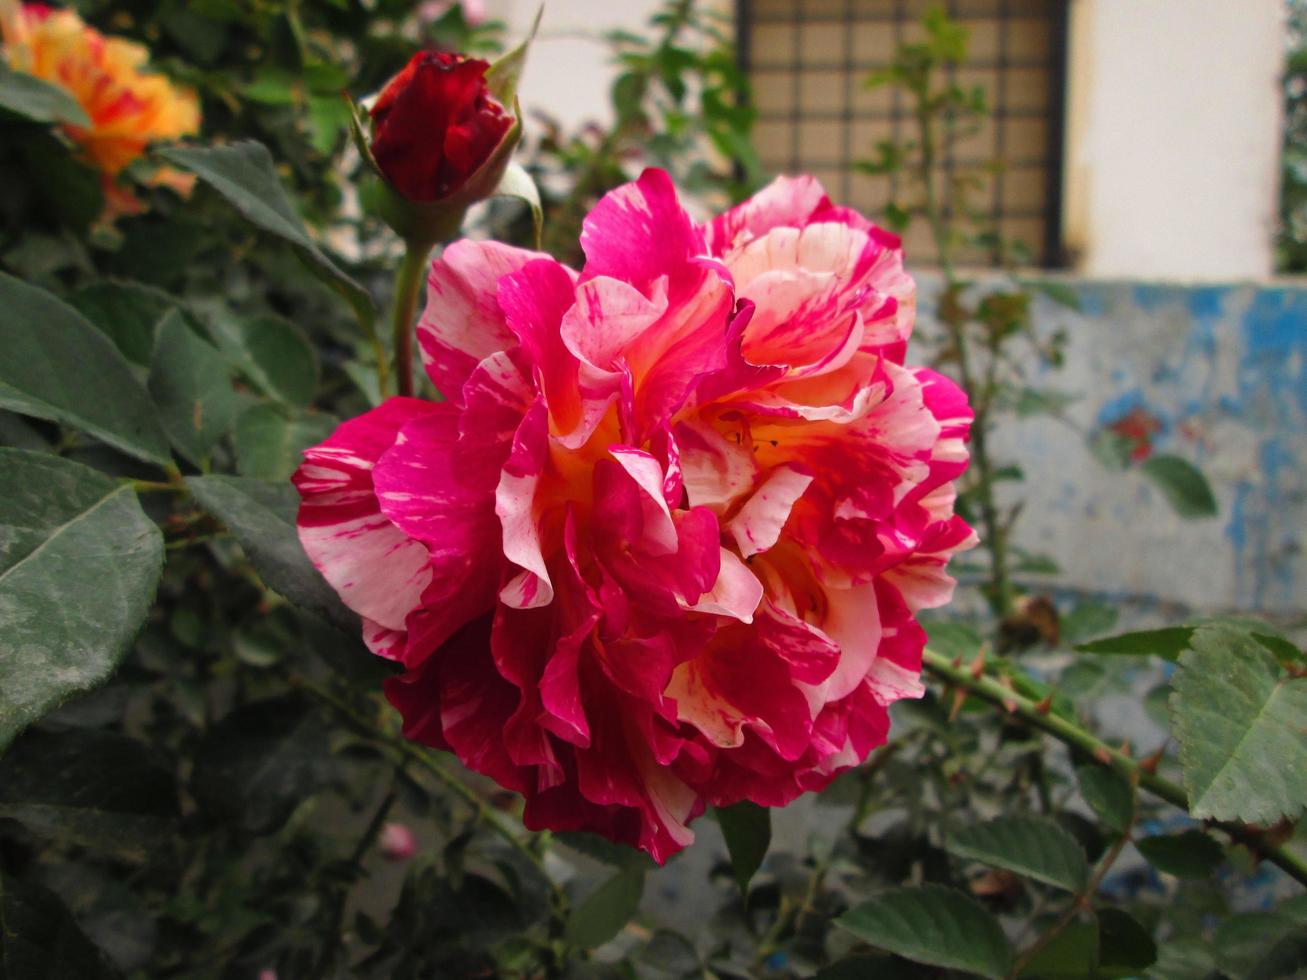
737, 0, 1067, 265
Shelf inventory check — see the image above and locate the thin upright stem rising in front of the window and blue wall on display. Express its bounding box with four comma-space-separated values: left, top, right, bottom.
915, 86, 1012, 619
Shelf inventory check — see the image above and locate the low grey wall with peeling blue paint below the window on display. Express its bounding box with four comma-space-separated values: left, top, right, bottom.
923, 280, 1307, 617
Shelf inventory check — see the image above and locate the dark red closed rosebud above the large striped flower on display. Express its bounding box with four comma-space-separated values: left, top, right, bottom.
371, 51, 514, 201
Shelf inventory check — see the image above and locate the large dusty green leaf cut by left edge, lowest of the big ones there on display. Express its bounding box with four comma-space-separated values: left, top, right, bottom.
0, 452, 163, 749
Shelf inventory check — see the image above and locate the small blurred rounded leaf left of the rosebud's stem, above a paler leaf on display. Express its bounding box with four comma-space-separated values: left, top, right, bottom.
209, 316, 318, 408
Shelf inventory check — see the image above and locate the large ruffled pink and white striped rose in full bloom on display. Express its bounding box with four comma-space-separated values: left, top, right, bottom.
295, 170, 975, 861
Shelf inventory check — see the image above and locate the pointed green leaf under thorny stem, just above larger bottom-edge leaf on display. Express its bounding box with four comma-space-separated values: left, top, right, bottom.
945, 817, 1089, 891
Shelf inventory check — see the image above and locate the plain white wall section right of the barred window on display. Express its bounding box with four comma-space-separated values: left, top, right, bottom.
1064, 0, 1285, 280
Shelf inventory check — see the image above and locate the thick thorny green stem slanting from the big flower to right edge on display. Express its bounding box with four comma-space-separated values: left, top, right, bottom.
923, 649, 1307, 886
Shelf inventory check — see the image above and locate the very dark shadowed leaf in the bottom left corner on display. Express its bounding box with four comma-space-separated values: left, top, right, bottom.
0, 874, 119, 980
